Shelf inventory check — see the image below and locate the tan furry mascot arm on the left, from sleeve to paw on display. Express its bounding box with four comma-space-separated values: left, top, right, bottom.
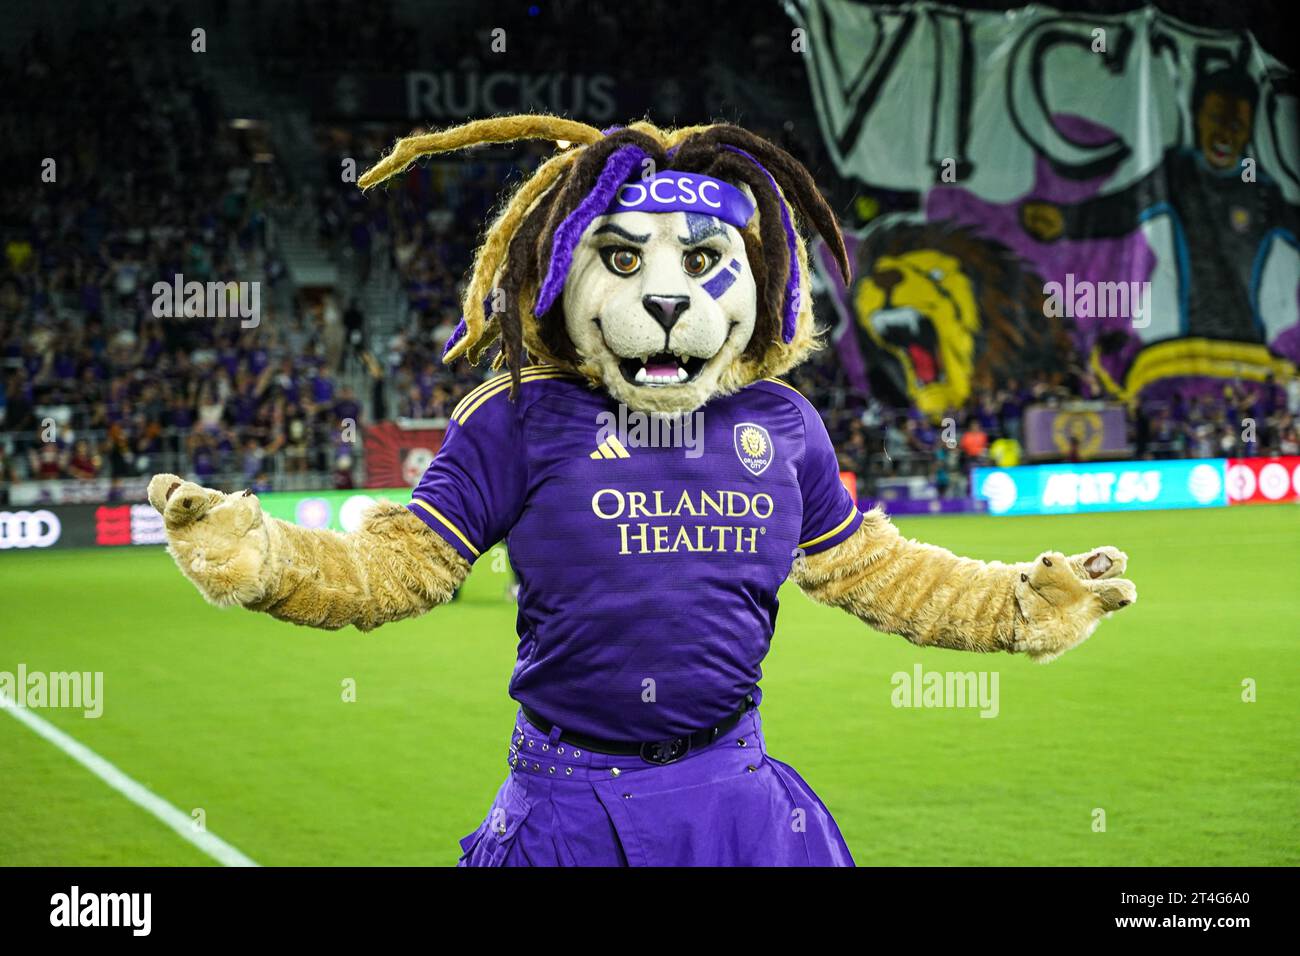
148, 475, 469, 631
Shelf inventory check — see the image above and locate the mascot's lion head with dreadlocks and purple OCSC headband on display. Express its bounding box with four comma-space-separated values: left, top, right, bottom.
360, 116, 849, 414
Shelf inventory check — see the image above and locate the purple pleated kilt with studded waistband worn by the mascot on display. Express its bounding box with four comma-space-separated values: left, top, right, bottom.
459, 708, 853, 866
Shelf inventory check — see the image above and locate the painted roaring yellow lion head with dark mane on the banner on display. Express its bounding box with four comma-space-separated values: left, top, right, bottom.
850, 222, 1070, 418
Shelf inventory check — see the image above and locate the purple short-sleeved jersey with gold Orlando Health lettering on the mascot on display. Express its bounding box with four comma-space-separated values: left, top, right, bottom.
408, 367, 862, 740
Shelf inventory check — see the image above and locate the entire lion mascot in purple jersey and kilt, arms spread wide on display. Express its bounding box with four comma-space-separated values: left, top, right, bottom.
148, 116, 1136, 865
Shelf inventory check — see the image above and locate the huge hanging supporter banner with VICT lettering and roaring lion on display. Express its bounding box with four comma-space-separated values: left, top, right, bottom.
785, 0, 1300, 418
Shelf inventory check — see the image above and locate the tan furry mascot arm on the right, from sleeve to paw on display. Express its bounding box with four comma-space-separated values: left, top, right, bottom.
793, 509, 1138, 662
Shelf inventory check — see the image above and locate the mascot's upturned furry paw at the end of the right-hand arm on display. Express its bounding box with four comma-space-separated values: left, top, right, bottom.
1011, 548, 1138, 663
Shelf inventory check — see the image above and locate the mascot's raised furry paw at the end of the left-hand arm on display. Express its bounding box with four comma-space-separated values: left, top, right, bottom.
148, 475, 270, 606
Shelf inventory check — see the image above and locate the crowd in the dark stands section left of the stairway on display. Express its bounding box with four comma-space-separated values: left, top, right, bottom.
0, 14, 363, 496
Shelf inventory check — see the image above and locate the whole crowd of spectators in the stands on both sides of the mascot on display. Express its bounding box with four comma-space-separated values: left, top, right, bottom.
0, 0, 1300, 512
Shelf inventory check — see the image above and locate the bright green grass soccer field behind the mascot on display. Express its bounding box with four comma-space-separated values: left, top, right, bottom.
0, 506, 1300, 865
